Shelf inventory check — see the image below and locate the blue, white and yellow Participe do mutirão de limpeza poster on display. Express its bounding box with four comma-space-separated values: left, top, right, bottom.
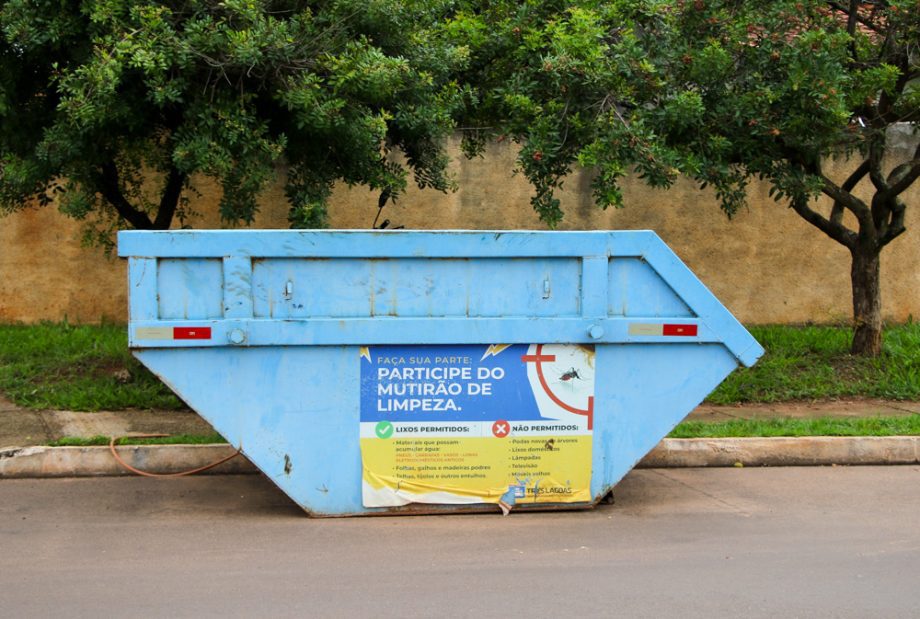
360, 344, 594, 513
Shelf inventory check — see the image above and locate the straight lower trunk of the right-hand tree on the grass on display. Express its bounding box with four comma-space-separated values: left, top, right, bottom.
850, 243, 882, 357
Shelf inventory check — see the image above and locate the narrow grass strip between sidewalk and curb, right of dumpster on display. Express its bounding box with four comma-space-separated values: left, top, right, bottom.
668, 415, 920, 438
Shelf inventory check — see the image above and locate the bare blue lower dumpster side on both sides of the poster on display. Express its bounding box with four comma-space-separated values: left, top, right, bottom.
135, 344, 737, 515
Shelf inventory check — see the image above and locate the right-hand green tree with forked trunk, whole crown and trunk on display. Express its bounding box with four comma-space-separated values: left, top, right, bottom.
446, 0, 920, 355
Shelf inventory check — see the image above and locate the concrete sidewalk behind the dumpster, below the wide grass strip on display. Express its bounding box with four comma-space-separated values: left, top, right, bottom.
0, 396, 920, 449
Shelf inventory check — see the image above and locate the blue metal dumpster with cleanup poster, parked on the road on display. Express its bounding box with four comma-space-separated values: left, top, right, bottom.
119, 231, 763, 516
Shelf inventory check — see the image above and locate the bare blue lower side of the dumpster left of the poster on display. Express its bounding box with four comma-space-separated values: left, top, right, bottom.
135, 347, 367, 515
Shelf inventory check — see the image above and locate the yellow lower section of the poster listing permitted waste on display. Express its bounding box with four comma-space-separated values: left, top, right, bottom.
361, 434, 592, 505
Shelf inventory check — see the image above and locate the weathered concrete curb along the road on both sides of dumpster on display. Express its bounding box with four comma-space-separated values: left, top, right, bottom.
0, 436, 920, 479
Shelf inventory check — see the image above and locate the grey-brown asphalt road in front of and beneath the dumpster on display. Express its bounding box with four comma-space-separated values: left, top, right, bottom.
0, 466, 920, 618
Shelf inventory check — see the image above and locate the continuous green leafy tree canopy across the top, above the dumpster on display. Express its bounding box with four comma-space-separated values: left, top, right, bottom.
0, 0, 920, 248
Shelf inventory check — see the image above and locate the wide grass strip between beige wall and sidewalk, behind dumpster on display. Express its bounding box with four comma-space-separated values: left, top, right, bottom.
0, 322, 920, 411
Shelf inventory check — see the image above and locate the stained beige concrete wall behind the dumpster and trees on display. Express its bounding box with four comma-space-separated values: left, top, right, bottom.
0, 136, 920, 324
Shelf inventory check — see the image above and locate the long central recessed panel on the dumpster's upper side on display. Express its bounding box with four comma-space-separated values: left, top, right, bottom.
253, 258, 581, 319
